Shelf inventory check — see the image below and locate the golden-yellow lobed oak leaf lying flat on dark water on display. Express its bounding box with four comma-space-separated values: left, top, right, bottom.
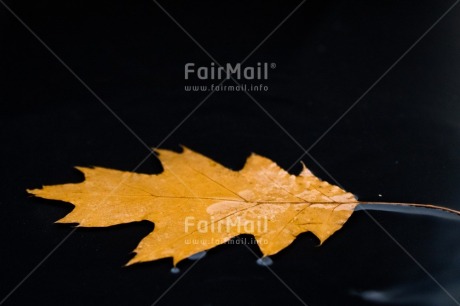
28, 148, 458, 265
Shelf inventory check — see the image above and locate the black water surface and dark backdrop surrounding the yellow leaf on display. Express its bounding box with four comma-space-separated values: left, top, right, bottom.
0, 0, 460, 306
